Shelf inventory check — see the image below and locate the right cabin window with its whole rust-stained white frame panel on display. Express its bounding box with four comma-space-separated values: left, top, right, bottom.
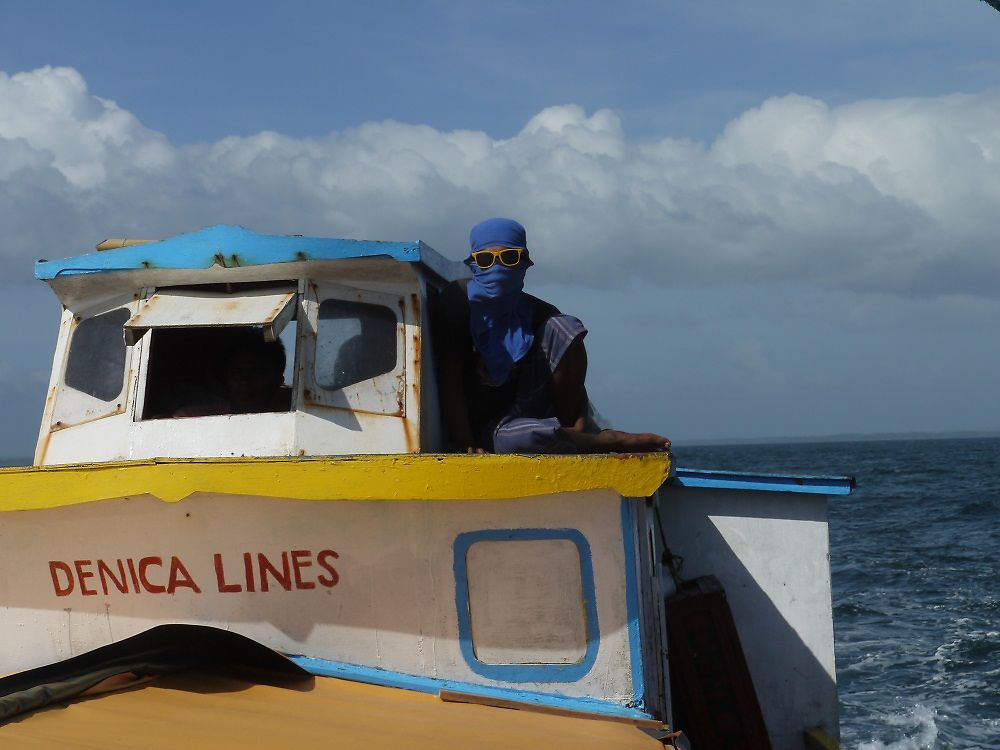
304, 284, 406, 416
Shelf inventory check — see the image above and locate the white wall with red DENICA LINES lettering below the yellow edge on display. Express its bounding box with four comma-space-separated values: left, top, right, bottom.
0, 488, 633, 706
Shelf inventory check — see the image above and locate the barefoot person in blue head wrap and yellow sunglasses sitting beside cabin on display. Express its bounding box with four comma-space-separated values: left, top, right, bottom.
434, 218, 670, 453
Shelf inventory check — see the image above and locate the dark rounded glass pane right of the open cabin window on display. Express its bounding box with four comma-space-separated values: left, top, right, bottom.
316, 299, 398, 391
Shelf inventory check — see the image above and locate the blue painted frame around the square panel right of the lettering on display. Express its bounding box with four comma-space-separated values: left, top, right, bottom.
454, 529, 601, 682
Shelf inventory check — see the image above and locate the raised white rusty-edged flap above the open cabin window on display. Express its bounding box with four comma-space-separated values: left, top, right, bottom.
125, 288, 297, 346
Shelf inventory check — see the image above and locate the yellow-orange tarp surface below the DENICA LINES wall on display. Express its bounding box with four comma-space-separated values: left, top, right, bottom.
0, 674, 663, 750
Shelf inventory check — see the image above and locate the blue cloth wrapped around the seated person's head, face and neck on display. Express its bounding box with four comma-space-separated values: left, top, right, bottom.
466, 218, 535, 385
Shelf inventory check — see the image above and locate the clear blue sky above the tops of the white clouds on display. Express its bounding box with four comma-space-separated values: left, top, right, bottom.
7, 0, 1000, 144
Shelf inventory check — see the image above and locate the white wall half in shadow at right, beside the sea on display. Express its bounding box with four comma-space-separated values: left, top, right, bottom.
659, 486, 839, 750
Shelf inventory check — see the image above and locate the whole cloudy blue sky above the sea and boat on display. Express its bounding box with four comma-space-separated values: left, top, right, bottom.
0, 0, 1000, 457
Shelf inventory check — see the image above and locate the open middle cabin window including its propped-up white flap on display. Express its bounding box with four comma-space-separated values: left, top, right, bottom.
137, 282, 298, 419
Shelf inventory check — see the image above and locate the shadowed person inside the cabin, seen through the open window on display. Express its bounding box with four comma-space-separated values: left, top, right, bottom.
173, 329, 291, 417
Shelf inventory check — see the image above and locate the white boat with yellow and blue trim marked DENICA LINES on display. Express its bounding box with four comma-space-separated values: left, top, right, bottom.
0, 225, 853, 750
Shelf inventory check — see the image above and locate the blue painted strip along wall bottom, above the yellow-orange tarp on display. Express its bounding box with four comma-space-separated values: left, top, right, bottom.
288, 655, 653, 719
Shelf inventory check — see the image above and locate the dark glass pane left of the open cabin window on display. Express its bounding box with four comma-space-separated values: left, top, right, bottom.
63, 308, 129, 401
